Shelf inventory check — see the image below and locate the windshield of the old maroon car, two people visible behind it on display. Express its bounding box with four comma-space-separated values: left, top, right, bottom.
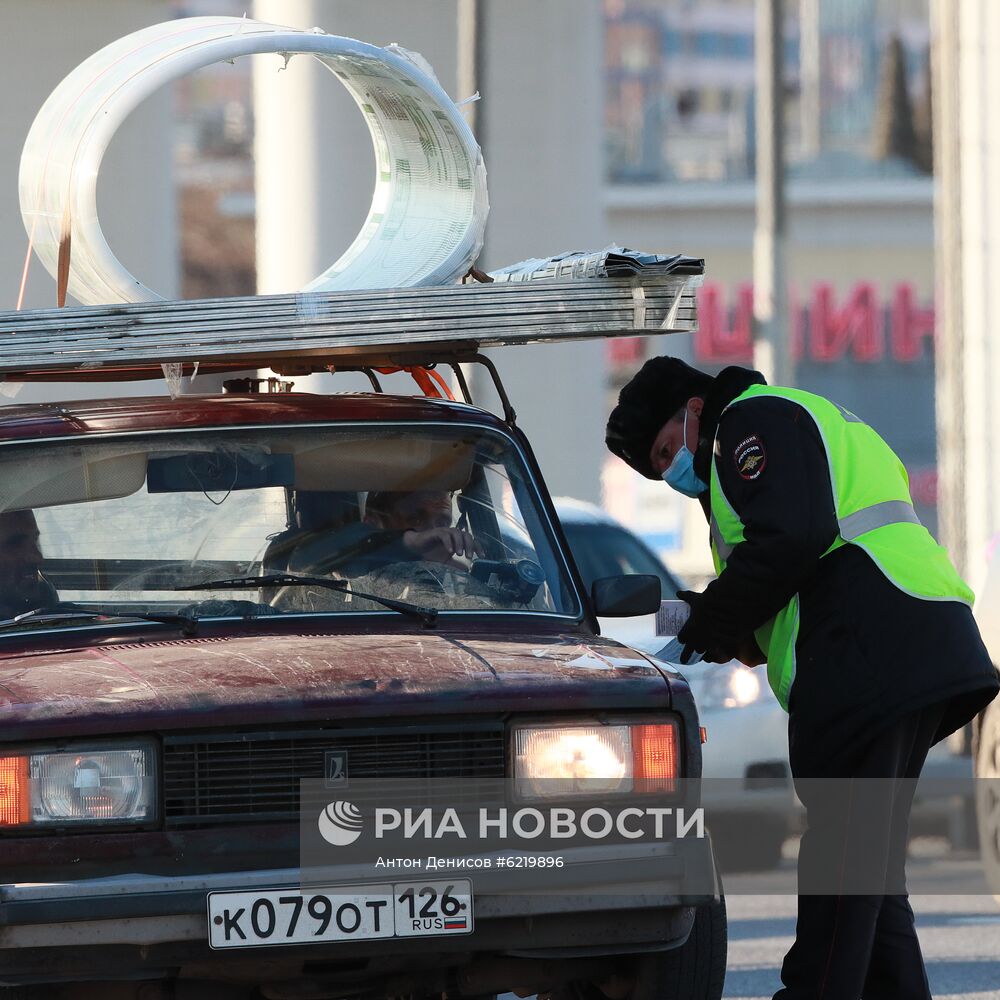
0, 422, 580, 630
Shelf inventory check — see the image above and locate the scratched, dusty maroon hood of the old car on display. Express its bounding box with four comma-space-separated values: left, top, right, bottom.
0, 632, 670, 741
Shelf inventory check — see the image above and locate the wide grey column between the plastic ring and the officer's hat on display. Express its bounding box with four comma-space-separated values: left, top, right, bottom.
476, 0, 609, 502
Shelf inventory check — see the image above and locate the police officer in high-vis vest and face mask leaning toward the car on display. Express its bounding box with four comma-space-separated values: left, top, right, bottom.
607, 357, 1000, 1000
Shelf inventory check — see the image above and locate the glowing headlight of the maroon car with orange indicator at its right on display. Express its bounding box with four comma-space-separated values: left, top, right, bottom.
514, 722, 679, 799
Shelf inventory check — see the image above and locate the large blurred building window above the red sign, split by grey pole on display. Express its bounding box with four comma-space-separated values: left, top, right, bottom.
605, 0, 931, 183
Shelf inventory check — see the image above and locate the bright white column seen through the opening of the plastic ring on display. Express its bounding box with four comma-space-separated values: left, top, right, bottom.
252, 0, 457, 294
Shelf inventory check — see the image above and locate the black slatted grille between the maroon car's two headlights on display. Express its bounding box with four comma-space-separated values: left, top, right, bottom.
163, 723, 505, 827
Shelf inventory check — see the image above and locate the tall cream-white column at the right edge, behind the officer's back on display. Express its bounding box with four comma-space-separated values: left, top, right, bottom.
934, 0, 1000, 589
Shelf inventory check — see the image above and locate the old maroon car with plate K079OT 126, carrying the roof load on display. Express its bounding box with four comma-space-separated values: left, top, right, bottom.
0, 384, 725, 1000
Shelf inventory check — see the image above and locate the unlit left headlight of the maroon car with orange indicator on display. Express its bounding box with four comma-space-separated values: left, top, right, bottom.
0, 743, 156, 829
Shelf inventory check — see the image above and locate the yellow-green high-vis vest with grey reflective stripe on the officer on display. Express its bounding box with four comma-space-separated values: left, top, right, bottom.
710, 385, 973, 712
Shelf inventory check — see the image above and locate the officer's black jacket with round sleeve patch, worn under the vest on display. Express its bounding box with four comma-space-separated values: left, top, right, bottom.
692, 368, 1000, 744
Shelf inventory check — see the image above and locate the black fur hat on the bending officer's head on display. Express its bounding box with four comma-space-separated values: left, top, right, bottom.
604, 357, 714, 479
